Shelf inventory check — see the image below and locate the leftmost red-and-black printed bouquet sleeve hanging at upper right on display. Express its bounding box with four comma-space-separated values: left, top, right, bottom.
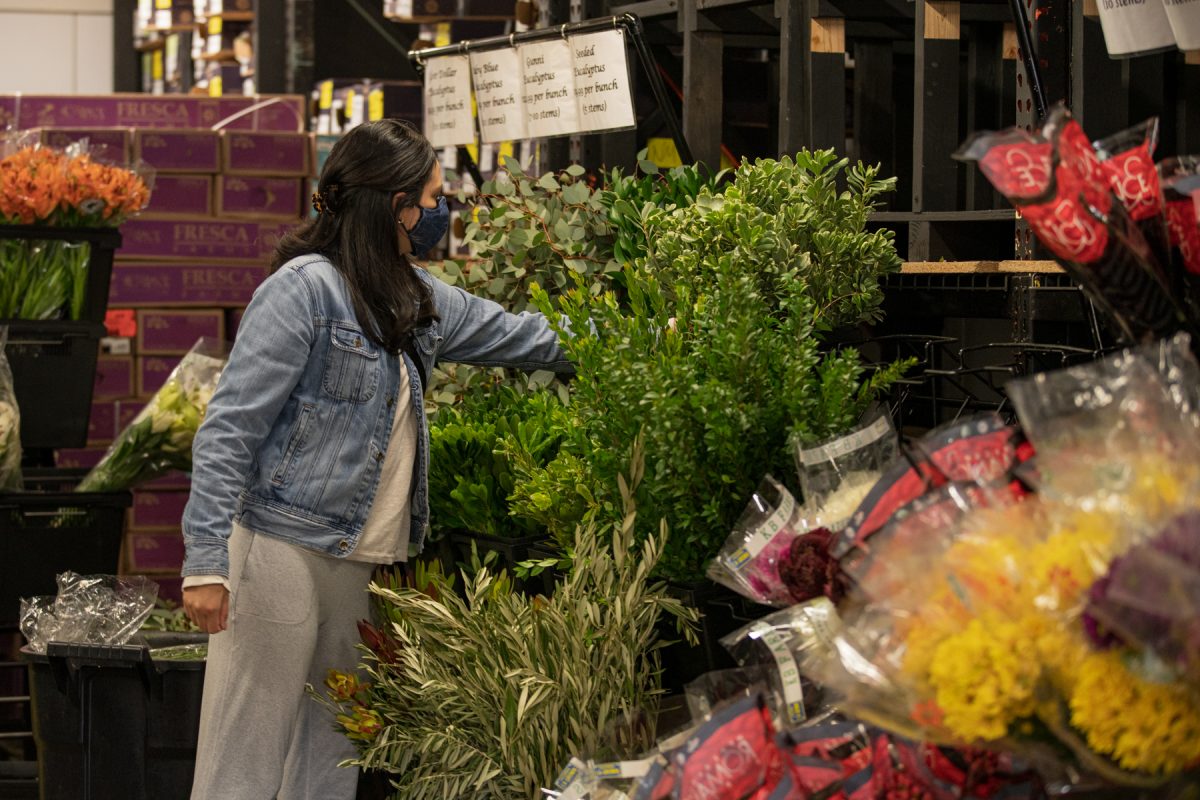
955, 106, 1189, 342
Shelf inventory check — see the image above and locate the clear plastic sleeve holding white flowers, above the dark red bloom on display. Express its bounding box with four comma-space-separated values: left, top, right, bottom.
796, 414, 899, 531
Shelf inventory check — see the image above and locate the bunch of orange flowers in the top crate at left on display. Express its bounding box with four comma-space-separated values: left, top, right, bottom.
0, 146, 150, 227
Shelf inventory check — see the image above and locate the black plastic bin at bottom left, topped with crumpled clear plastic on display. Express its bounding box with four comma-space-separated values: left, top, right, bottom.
22, 632, 208, 800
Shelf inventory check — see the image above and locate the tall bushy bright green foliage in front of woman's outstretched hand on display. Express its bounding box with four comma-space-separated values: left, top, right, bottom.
512, 151, 905, 583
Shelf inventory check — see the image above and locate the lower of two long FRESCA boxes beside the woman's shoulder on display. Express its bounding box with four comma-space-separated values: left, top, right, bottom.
108, 260, 268, 308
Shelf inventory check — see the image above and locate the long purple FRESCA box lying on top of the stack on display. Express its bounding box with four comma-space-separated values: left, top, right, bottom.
0, 94, 306, 131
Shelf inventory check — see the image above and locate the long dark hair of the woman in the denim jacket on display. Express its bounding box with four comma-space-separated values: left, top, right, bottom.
271, 120, 437, 353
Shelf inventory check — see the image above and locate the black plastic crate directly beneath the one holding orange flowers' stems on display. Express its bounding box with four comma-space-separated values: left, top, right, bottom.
0, 319, 106, 450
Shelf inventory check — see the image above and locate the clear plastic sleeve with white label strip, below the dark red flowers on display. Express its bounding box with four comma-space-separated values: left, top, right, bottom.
721, 597, 840, 730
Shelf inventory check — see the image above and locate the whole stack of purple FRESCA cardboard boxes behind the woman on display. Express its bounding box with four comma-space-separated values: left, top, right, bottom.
0, 95, 316, 597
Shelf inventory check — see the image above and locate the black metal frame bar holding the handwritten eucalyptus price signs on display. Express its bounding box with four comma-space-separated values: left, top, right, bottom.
408, 13, 694, 165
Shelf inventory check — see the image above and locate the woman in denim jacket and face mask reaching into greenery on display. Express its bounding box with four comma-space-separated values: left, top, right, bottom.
182, 120, 571, 800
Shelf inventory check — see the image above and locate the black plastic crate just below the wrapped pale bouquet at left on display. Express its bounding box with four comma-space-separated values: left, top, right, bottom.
0, 470, 133, 622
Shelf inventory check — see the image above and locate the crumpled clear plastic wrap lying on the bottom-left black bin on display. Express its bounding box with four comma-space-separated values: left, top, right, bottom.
20, 572, 158, 652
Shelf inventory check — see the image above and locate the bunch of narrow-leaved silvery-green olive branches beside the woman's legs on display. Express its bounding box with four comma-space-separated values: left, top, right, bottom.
323, 446, 695, 800
